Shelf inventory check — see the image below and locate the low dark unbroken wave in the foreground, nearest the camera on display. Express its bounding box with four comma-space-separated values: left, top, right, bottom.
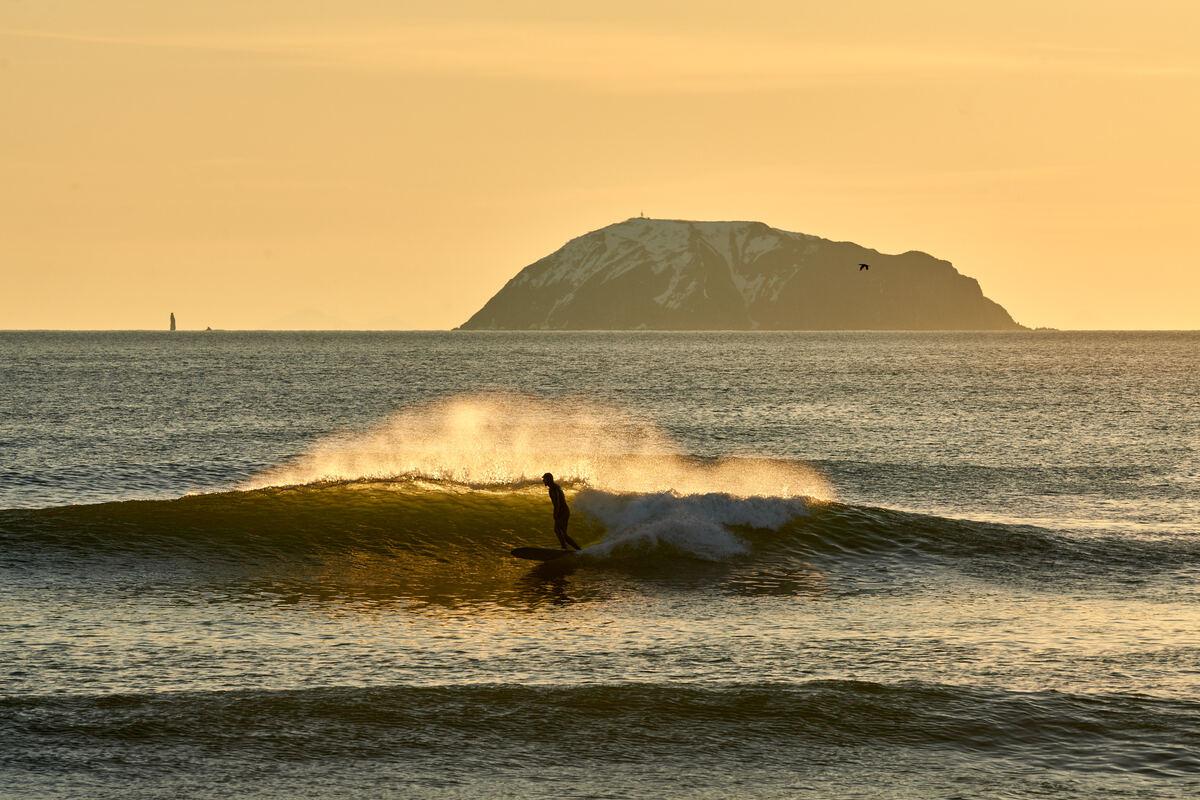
0, 680, 1200, 777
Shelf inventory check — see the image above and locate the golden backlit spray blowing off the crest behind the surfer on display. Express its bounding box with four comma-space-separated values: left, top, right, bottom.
241, 395, 833, 499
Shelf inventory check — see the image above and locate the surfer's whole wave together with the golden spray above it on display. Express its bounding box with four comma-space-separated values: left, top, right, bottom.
0, 395, 1200, 595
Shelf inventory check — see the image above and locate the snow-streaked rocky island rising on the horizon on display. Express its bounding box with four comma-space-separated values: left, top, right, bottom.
461, 218, 1022, 330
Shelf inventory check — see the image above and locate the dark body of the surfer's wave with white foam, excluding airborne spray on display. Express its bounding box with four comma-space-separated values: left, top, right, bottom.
0, 479, 1200, 582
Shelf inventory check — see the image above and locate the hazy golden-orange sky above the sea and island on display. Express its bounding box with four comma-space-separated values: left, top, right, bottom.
0, 0, 1200, 329
